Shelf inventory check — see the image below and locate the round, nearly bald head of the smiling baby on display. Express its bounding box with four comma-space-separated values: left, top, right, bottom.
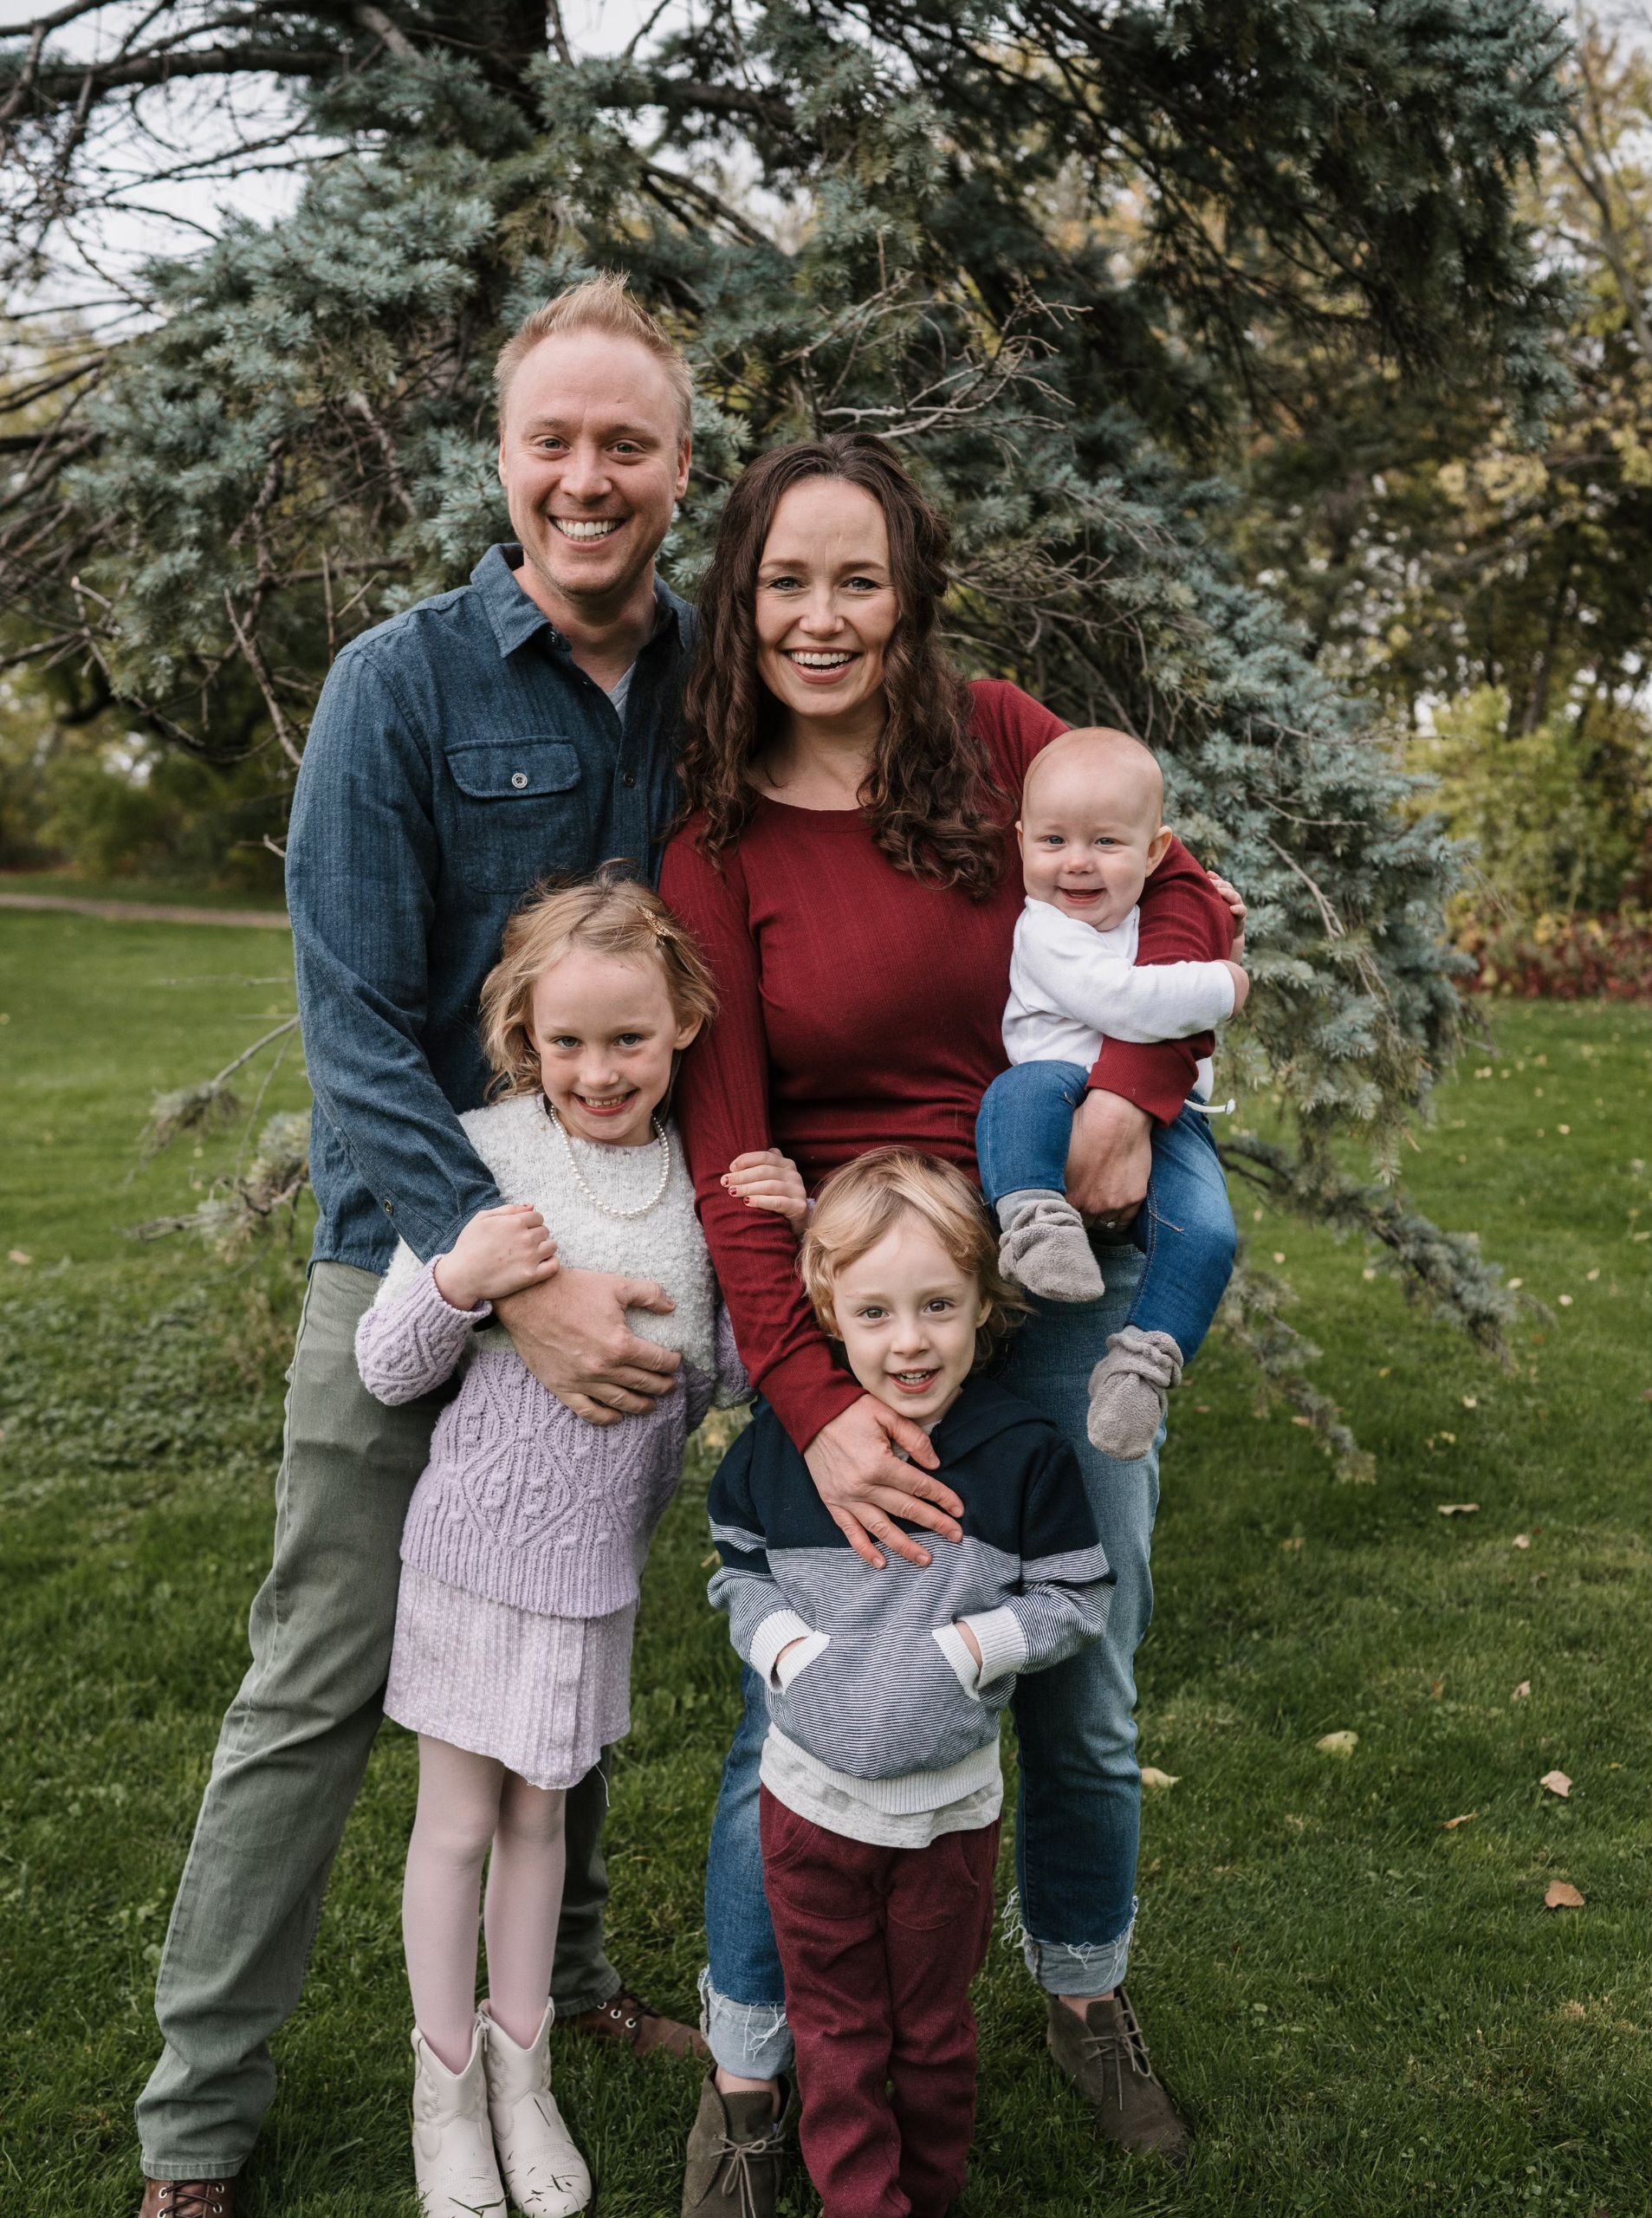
1015, 732, 1171, 931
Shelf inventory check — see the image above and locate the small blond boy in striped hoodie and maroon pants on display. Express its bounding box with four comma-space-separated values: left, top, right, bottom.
709, 1149, 1111, 2218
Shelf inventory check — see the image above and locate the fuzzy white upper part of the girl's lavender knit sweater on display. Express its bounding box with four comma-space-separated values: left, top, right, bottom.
377, 1093, 716, 1378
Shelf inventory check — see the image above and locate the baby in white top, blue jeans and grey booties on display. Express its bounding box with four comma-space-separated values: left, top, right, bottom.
975, 730, 1248, 1462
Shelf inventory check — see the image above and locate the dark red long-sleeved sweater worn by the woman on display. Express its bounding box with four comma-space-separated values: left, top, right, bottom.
661, 678, 1231, 1449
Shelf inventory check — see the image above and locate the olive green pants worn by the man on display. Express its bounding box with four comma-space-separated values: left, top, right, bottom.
138, 1262, 619, 2180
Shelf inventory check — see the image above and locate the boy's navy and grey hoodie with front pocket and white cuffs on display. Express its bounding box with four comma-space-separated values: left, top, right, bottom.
709, 1378, 1113, 1814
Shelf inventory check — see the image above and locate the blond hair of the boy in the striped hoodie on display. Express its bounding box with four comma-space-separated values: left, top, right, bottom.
799, 1147, 1027, 1371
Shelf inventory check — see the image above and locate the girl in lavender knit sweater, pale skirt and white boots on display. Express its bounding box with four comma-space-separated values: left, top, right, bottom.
357, 865, 749, 2218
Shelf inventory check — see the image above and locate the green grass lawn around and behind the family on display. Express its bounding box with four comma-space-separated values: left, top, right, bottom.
0, 914, 1652, 2218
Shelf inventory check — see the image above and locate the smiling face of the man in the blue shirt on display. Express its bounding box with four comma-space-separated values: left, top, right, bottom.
499, 330, 690, 623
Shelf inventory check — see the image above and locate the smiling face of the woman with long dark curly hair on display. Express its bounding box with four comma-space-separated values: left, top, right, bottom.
756, 477, 900, 721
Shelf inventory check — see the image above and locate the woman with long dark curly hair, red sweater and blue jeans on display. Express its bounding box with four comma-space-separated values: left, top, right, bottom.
661, 435, 1208, 2214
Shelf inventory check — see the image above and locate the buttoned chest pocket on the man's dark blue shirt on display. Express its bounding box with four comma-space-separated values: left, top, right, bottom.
444, 734, 601, 894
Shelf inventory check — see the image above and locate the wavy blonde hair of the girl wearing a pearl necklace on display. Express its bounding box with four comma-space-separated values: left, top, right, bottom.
470, 863, 716, 1100
